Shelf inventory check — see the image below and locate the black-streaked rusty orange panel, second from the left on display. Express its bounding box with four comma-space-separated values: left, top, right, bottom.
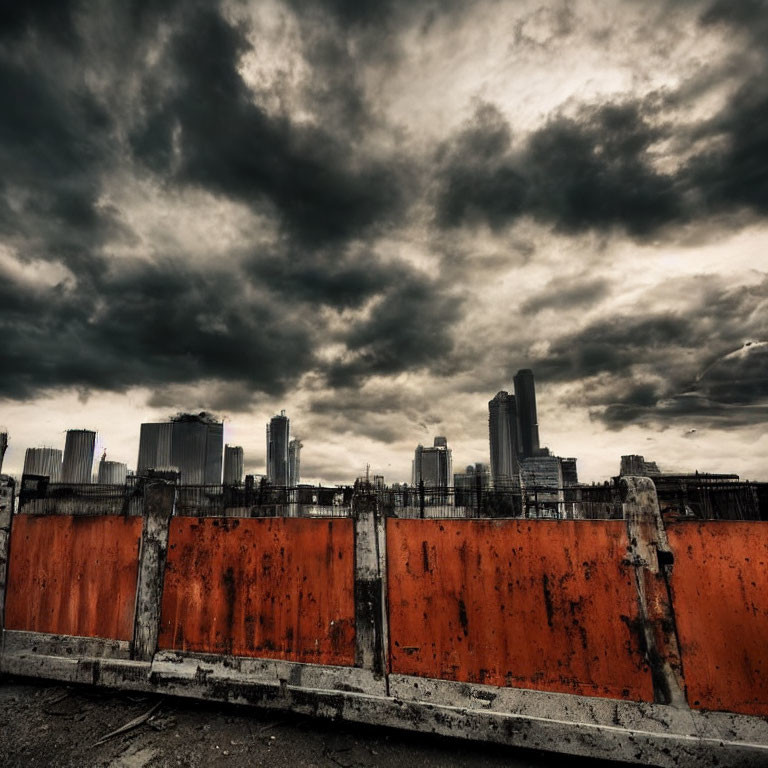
159, 517, 355, 666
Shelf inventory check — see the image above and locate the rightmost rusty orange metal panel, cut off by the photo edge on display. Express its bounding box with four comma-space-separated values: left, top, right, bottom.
667, 520, 768, 715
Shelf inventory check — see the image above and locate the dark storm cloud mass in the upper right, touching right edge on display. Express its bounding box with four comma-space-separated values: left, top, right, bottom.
436, 0, 768, 238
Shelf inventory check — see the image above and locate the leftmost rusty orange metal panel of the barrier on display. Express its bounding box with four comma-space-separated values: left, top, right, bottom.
5, 515, 142, 640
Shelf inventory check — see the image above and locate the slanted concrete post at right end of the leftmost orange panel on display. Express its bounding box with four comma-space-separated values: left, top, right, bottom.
132, 482, 176, 661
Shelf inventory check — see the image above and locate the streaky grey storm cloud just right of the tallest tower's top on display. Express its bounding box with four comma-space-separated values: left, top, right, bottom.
533, 278, 768, 428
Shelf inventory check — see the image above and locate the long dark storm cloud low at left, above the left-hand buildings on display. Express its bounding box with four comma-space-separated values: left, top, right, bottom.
0, 261, 313, 407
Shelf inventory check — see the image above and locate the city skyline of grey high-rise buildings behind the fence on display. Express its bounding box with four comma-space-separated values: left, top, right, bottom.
0, 369, 754, 488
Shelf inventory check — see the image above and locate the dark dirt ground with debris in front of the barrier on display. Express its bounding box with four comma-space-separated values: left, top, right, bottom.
0, 677, 632, 768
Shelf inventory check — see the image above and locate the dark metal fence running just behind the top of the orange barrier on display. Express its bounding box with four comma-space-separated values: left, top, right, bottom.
19, 475, 768, 520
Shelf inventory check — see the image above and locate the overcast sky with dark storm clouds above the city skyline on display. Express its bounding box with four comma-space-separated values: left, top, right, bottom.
0, 0, 768, 482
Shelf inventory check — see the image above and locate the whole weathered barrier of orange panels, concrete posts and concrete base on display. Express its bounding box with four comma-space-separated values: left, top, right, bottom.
0, 478, 768, 767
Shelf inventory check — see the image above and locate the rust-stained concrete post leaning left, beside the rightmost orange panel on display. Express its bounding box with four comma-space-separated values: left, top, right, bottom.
620, 477, 688, 707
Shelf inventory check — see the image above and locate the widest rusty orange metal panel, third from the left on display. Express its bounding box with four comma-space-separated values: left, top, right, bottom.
387, 519, 653, 701
